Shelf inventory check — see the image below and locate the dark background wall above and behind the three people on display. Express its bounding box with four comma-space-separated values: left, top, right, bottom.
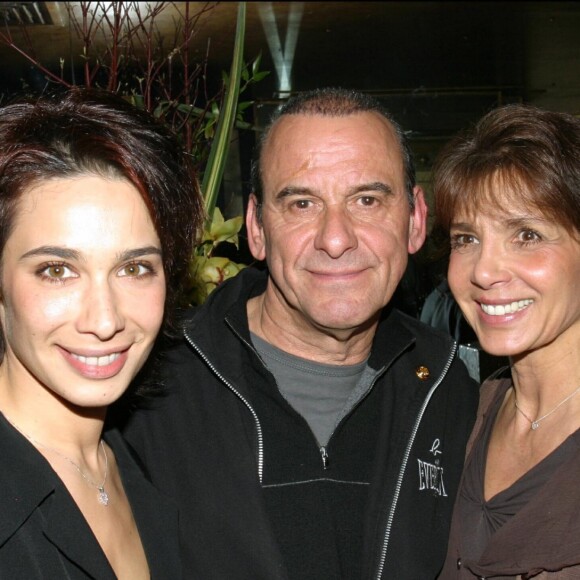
0, 0, 580, 220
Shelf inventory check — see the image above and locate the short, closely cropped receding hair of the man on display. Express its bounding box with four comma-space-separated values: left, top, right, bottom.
252, 87, 416, 208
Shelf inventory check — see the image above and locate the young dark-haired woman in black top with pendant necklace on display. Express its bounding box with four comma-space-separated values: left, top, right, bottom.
0, 89, 202, 580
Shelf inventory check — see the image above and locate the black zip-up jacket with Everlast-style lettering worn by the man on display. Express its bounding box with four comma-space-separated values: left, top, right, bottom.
125, 268, 478, 580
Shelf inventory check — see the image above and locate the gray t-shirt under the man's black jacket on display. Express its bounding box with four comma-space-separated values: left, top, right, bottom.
251, 333, 376, 447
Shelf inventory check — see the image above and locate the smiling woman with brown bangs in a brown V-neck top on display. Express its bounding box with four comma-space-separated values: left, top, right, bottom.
434, 105, 580, 579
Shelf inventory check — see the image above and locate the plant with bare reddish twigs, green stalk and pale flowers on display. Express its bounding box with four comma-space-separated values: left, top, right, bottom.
0, 1, 268, 304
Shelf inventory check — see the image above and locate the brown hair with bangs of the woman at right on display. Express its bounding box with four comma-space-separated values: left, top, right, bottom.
433, 104, 580, 239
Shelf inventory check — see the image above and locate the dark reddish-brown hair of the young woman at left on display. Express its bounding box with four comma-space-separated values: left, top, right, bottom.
0, 88, 203, 360
